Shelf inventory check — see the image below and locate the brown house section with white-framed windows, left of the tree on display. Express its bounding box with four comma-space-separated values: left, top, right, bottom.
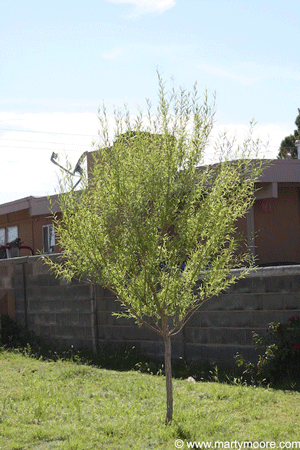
0, 195, 60, 258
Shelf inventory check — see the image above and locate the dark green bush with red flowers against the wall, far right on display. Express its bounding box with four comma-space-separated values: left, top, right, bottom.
236, 316, 300, 387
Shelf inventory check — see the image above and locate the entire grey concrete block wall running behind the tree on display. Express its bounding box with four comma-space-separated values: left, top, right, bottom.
0, 255, 300, 364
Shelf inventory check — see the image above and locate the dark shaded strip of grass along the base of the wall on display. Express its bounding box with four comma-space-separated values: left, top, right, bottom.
0, 316, 300, 391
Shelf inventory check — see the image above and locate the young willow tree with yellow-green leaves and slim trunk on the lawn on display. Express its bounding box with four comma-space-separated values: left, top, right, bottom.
48, 77, 262, 423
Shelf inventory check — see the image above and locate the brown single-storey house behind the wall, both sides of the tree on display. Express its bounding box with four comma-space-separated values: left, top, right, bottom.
0, 156, 300, 266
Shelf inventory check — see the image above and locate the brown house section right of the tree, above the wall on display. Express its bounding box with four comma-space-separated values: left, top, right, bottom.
87, 151, 300, 266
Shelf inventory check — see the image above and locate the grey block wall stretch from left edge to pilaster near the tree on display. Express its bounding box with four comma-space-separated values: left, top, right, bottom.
0, 255, 92, 349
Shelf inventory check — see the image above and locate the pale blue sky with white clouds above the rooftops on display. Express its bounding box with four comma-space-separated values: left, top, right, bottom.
0, 0, 300, 204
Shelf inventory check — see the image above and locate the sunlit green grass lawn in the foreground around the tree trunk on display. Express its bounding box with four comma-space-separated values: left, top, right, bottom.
0, 351, 300, 450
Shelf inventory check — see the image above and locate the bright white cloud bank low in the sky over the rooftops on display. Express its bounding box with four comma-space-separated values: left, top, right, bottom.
0, 111, 291, 204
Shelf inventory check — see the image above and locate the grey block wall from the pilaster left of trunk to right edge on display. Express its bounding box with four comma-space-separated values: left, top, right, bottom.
96, 266, 300, 365
